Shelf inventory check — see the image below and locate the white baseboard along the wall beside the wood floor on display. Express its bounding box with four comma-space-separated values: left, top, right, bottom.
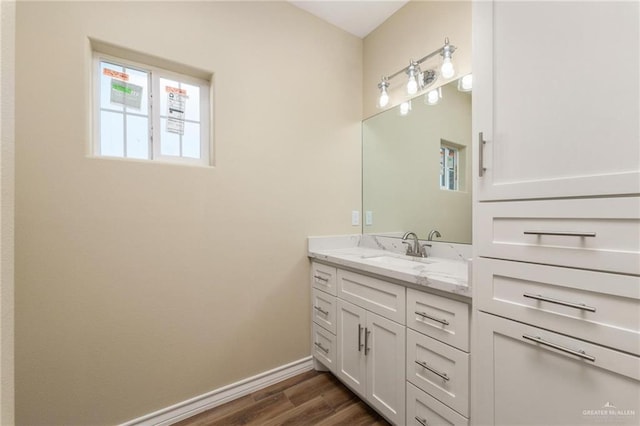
120, 356, 313, 426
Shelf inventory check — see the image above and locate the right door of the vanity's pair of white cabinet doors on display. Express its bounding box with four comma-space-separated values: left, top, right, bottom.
365, 312, 405, 425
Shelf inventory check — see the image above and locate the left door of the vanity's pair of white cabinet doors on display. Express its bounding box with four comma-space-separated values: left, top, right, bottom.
336, 299, 367, 397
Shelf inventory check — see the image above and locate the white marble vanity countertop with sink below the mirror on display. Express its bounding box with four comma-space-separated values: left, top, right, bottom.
308, 235, 471, 298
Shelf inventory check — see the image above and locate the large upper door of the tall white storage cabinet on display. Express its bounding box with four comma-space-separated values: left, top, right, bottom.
473, 1, 640, 201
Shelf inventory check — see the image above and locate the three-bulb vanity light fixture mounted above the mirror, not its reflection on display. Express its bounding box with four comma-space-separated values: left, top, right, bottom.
378, 38, 456, 108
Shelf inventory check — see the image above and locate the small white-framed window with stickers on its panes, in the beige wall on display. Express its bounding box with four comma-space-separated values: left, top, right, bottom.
93, 53, 211, 165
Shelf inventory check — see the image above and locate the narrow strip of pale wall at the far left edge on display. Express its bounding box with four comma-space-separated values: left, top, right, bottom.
0, 1, 15, 426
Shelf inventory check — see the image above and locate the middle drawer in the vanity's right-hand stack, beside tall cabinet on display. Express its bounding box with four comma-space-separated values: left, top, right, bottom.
407, 329, 469, 417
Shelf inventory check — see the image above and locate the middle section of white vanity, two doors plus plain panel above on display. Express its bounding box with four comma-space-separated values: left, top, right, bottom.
336, 270, 405, 424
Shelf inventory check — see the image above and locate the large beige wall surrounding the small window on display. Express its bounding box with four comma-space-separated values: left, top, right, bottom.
16, 2, 362, 425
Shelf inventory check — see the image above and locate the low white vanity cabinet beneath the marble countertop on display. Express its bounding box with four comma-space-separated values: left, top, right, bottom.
311, 262, 470, 426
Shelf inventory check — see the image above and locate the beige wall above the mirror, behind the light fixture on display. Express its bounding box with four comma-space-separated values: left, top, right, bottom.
363, 0, 471, 117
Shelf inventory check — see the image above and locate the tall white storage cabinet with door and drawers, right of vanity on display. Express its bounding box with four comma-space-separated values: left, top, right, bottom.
471, 1, 640, 425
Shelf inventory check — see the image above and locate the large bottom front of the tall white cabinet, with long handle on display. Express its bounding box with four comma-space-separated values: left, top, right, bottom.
472, 313, 640, 425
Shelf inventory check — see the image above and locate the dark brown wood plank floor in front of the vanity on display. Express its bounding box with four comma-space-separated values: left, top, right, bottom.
176, 371, 389, 426
